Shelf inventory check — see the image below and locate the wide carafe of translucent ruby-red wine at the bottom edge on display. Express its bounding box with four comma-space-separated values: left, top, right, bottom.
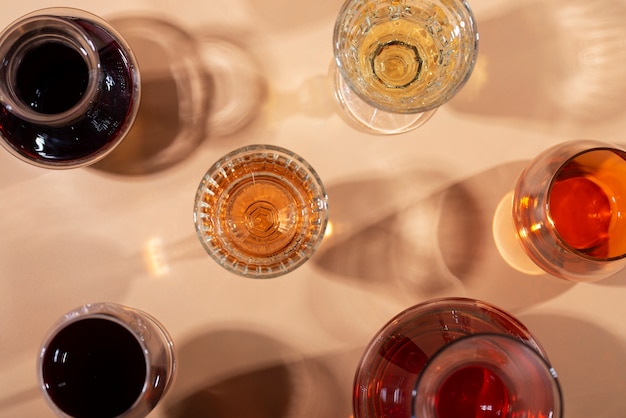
353, 298, 562, 418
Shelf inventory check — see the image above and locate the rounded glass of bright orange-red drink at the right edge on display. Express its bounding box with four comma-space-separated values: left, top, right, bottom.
513, 140, 626, 282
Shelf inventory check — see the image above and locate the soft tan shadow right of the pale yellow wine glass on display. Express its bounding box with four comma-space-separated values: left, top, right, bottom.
446, 0, 626, 132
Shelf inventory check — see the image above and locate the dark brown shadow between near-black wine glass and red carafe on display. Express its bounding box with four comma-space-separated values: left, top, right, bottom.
163, 325, 360, 418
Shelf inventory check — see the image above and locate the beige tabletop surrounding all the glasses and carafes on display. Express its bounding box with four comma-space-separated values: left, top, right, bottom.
0, 0, 626, 418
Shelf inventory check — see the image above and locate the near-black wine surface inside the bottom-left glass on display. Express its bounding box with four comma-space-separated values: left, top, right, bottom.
41, 317, 147, 418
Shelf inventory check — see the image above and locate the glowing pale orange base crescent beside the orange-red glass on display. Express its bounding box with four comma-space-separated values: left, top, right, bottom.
492, 191, 546, 276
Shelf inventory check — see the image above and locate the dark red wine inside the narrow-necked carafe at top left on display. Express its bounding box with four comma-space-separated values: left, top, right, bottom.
0, 18, 138, 165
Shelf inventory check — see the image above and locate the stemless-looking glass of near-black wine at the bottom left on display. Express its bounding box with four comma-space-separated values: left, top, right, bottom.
38, 303, 175, 418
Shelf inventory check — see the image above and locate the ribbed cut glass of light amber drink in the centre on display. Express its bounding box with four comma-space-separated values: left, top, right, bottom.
194, 145, 328, 278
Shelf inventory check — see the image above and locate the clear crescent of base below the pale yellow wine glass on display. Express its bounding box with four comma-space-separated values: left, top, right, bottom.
330, 63, 437, 135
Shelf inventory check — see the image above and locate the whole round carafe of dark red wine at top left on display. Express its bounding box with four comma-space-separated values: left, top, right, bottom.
0, 8, 140, 168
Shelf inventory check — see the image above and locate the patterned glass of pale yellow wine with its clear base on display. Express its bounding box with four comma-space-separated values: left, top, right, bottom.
333, 0, 478, 134
